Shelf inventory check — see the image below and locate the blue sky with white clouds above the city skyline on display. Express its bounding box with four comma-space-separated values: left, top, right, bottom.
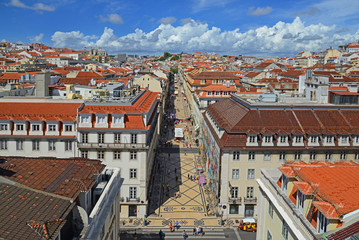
0, 0, 359, 57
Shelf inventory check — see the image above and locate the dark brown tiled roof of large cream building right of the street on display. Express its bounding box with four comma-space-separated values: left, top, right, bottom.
205, 98, 359, 147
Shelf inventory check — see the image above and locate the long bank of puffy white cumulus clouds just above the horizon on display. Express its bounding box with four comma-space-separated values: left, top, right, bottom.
52, 17, 359, 56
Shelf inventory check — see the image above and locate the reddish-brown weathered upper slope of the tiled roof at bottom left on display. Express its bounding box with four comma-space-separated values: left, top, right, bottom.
0, 157, 105, 199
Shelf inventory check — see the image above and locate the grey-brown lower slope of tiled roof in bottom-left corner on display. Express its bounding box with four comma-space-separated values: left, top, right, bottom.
0, 183, 73, 239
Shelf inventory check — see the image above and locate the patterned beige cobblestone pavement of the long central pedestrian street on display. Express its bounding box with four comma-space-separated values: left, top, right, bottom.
147, 74, 220, 227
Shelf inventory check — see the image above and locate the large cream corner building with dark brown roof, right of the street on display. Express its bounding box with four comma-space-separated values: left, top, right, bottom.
202, 95, 359, 218
